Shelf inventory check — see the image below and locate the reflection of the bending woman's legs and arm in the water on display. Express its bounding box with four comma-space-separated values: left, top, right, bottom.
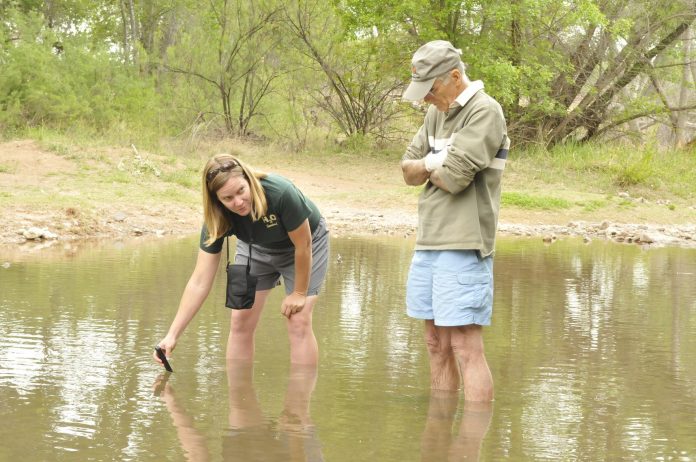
155, 361, 324, 462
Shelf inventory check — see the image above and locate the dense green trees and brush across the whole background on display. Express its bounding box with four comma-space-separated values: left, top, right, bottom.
0, 0, 696, 150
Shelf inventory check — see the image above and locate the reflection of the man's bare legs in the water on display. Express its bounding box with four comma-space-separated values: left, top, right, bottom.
421, 390, 493, 462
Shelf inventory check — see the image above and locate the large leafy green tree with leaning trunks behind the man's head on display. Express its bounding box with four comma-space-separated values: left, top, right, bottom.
339, 0, 696, 145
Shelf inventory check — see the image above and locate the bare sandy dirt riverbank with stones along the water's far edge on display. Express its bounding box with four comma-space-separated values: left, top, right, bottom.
0, 140, 696, 255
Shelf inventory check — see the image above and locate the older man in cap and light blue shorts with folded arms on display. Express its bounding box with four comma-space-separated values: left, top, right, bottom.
401, 40, 510, 401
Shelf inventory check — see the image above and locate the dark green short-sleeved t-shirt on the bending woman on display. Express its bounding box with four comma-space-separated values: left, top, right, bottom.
200, 174, 321, 253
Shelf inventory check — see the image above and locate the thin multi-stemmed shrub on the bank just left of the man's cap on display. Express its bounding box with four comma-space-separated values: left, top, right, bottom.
286, 0, 410, 140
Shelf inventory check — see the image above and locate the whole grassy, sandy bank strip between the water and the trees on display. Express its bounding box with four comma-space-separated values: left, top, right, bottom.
0, 131, 696, 229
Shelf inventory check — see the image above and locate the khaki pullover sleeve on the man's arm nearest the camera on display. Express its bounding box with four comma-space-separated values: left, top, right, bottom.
438, 101, 506, 194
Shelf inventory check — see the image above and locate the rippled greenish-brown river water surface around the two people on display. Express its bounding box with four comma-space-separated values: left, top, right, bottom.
6, 239, 696, 460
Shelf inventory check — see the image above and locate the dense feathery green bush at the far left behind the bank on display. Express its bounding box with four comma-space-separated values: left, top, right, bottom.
0, 3, 164, 134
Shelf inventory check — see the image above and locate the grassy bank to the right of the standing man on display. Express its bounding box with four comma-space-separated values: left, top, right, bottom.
503, 144, 696, 223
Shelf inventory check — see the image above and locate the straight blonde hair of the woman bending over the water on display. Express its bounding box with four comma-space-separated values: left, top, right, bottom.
202, 154, 268, 245
